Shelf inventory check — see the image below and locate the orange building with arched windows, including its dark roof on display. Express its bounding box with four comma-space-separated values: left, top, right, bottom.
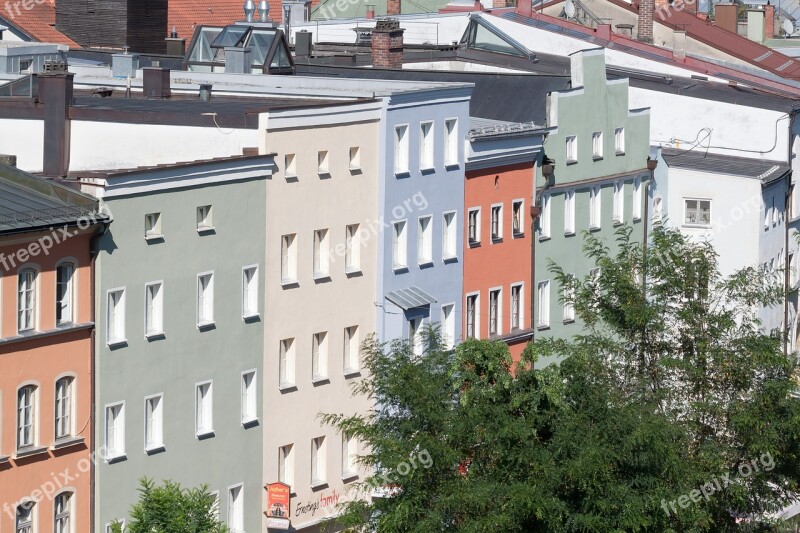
0, 167, 105, 533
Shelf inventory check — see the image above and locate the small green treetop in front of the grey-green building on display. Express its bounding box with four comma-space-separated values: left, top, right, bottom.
112, 478, 228, 533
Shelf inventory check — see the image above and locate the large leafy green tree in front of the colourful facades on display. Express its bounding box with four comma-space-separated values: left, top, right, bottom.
322, 227, 800, 532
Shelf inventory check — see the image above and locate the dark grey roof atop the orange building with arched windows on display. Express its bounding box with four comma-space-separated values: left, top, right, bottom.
0, 163, 107, 234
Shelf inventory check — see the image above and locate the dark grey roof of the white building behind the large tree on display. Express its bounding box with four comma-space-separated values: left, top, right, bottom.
661, 148, 790, 183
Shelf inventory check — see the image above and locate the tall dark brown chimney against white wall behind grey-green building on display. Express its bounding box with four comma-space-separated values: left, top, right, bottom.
39, 65, 74, 178
